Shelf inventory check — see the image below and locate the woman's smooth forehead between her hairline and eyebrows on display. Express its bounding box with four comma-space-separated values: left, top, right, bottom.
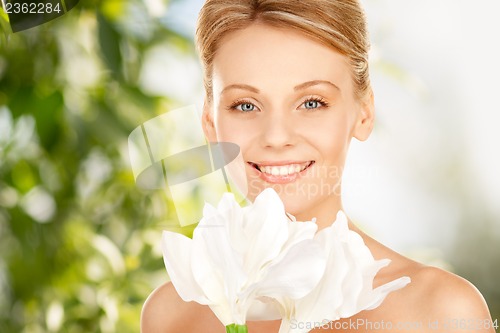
213, 23, 353, 92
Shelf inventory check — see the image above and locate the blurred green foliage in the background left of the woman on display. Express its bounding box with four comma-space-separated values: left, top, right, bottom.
0, 0, 194, 333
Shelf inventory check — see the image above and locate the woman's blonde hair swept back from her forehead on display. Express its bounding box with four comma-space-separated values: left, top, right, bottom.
196, 0, 370, 101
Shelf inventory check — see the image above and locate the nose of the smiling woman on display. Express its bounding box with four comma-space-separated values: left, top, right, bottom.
261, 111, 297, 148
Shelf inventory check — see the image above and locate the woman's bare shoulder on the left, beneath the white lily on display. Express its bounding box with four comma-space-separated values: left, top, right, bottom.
141, 282, 220, 333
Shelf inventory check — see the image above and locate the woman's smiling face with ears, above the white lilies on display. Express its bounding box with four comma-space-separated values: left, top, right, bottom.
204, 24, 373, 223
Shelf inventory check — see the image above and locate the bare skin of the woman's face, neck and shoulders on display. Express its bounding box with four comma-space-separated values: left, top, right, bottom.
141, 24, 495, 333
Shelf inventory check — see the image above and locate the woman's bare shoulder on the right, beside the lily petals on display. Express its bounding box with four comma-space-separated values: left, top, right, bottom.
364, 238, 495, 333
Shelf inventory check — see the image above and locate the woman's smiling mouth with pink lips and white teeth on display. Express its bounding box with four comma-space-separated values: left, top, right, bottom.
248, 161, 314, 184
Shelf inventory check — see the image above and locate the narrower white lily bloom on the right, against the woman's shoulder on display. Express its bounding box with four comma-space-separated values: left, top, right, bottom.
278, 211, 410, 333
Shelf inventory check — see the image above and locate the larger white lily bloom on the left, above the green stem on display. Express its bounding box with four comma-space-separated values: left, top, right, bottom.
162, 189, 326, 326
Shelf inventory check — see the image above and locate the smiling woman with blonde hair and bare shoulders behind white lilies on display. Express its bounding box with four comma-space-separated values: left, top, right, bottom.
142, 0, 494, 333
